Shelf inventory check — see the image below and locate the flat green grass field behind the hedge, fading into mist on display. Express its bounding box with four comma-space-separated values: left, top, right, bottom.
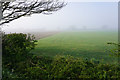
33, 31, 118, 63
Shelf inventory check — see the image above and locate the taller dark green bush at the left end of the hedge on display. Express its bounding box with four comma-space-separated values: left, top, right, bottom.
2, 33, 36, 73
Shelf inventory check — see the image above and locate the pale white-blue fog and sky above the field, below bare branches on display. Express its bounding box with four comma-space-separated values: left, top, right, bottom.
2, 2, 118, 33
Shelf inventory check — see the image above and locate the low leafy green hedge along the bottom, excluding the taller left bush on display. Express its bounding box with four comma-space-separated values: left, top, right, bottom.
21, 56, 120, 80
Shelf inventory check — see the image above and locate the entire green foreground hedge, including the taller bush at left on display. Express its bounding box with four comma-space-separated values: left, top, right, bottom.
2, 33, 120, 80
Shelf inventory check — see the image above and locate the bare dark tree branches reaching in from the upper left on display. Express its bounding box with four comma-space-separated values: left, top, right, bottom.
0, 0, 66, 25
